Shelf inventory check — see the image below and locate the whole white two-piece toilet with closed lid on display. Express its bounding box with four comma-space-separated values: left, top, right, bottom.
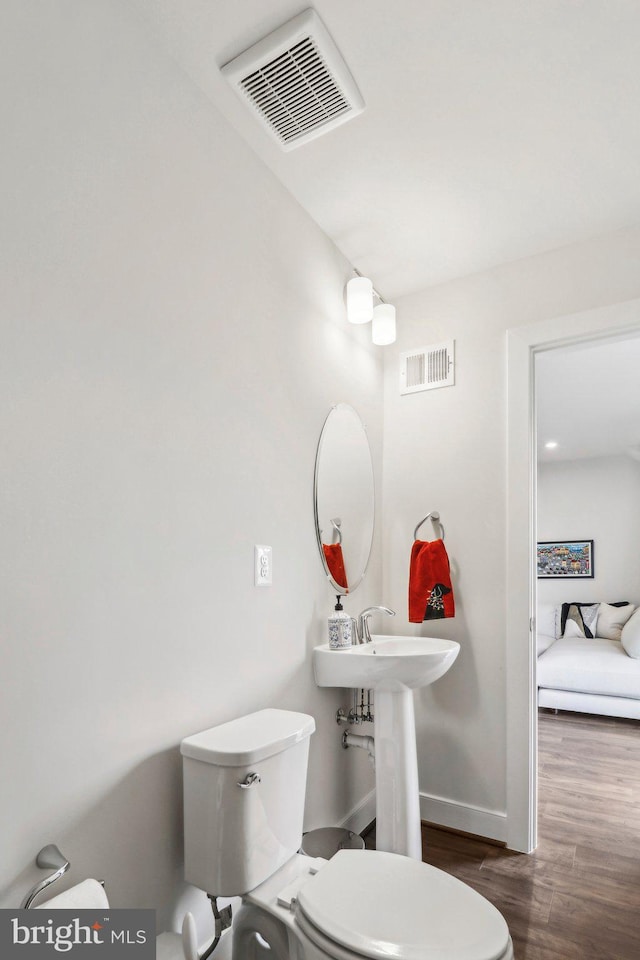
181, 709, 513, 960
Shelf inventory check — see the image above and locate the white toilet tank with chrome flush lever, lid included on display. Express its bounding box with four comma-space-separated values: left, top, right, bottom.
180, 709, 315, 897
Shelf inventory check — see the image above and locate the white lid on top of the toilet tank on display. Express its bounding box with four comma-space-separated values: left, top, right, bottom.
180, 709, 316, 767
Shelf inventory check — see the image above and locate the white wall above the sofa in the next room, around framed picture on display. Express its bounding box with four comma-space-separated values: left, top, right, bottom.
538, 456, 640, 604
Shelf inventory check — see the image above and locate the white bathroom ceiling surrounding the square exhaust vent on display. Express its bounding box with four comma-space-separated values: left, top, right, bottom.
132, 0, 640, 299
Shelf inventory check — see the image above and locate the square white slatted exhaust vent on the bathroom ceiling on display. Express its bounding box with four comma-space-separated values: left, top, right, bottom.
222, 9, 364, 150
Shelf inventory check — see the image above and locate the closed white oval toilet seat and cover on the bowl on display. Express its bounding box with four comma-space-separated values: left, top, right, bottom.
295, 850, 513, 960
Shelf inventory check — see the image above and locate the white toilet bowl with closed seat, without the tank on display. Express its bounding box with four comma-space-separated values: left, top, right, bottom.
233, 850, 513, 960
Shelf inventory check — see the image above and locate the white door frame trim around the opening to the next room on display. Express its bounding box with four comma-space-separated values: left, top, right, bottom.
506, 299, 640, 853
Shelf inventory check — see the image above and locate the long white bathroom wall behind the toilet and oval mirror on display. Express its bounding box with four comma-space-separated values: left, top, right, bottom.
0, 0, 382, 929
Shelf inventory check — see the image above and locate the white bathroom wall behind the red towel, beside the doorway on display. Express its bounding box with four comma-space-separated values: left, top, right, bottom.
383, 229, 640, 838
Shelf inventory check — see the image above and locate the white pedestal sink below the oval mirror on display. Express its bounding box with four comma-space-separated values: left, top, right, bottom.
313, 635, 460, 860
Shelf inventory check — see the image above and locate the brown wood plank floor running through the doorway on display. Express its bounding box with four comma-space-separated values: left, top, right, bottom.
369, 711, 640, 960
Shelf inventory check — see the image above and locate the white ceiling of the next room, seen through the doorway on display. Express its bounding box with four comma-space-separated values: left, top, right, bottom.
535, 336, 640, 463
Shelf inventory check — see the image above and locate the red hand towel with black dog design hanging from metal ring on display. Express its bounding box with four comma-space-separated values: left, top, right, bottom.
409, 540, 456, 623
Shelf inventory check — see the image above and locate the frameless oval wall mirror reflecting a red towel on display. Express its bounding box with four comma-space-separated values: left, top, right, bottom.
314, 403, 375, 594
